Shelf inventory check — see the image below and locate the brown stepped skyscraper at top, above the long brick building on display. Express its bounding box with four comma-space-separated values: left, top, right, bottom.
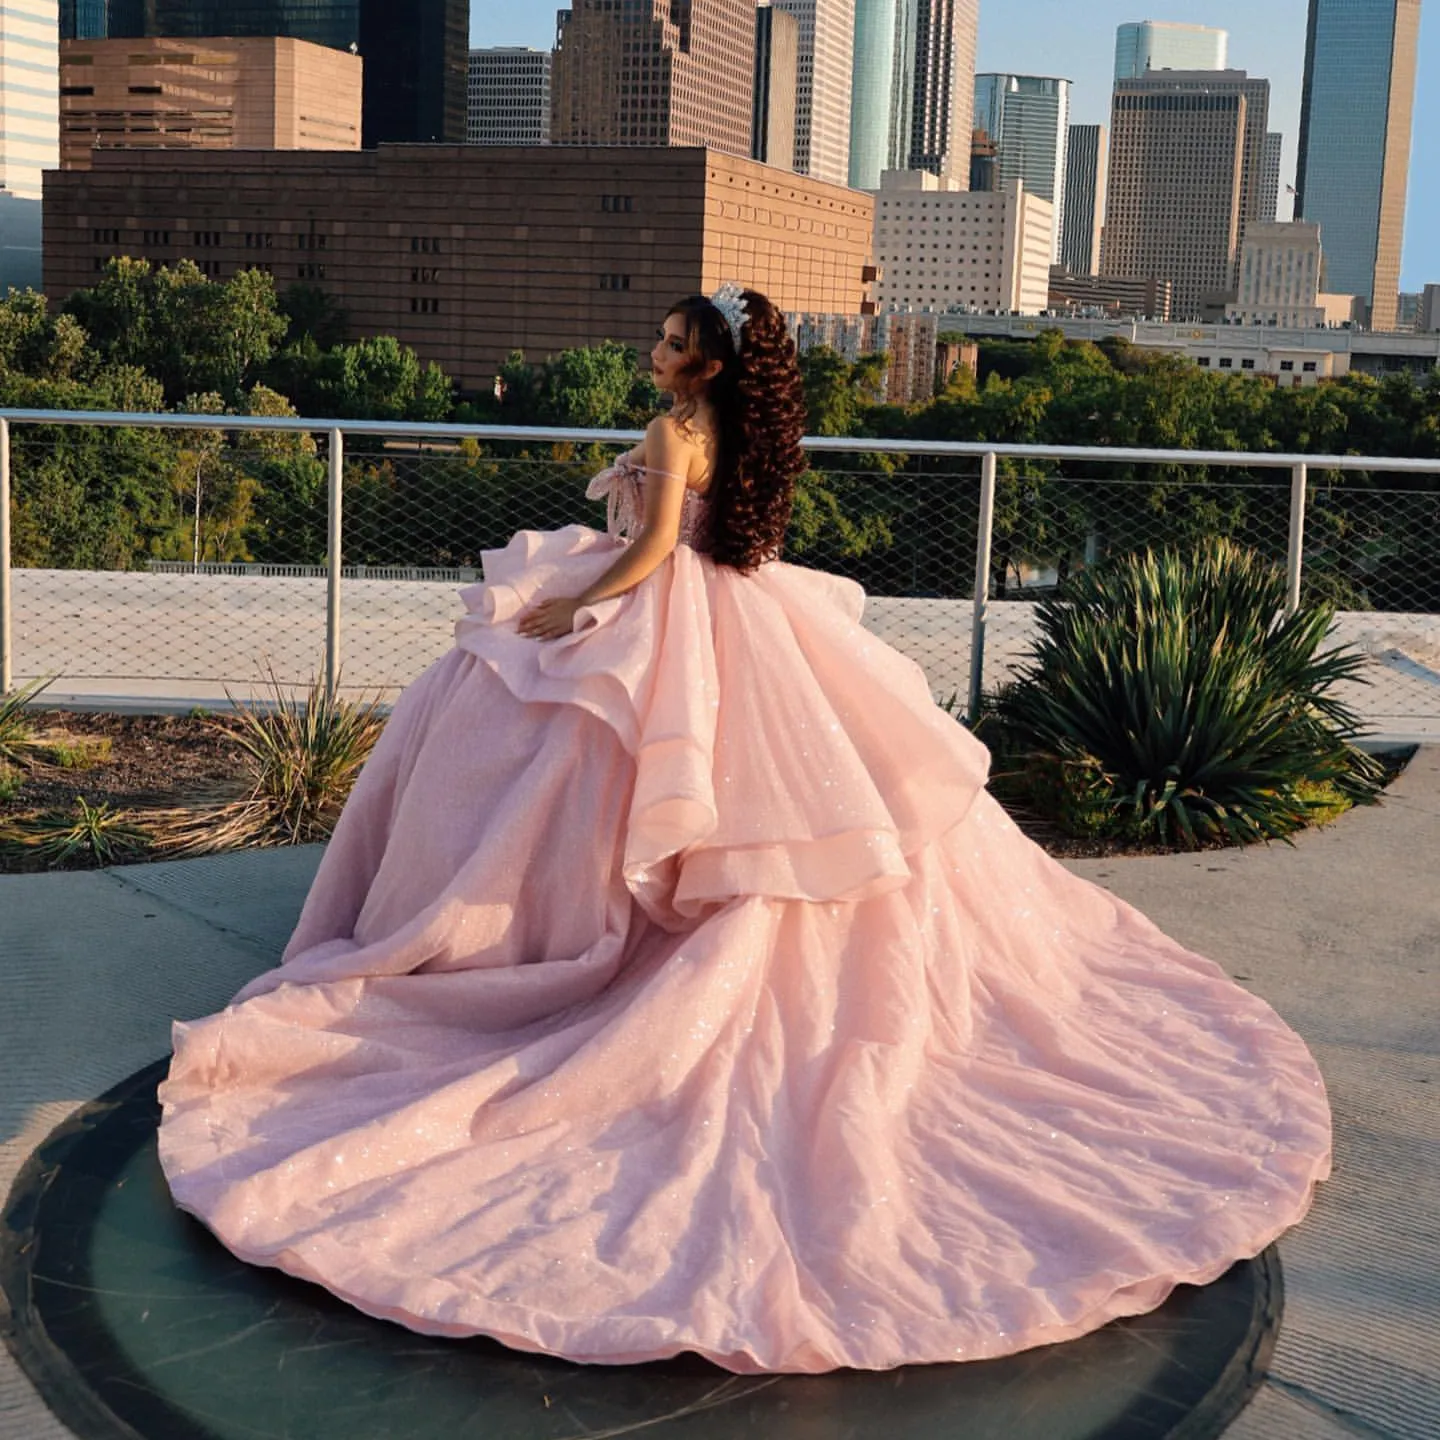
550, 0, 755, 156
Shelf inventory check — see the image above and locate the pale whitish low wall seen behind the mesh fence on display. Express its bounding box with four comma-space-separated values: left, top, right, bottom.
13, 570, 1440, 740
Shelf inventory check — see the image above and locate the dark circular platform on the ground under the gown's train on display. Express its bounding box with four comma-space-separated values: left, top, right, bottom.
0, 1063, 1282, 1440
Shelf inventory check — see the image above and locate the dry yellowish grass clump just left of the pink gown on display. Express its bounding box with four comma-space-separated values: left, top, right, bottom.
153, 672, 384, 854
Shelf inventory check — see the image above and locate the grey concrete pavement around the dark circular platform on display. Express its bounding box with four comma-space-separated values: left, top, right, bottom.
0, 749, 1440, 1440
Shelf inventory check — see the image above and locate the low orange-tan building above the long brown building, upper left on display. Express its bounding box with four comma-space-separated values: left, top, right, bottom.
60, 36, 363, 170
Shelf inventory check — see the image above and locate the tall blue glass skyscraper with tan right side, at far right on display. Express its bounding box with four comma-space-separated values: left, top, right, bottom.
1295, 0, 1420, 330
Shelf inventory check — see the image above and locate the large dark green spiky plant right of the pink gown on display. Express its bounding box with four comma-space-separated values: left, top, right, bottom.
995, 540, 1384, 847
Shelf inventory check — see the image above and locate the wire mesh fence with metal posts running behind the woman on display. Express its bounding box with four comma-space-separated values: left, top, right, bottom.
0, 415, 1440, 736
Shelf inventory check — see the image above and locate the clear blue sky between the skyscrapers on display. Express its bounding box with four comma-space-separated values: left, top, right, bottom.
469, 0, 1440, 291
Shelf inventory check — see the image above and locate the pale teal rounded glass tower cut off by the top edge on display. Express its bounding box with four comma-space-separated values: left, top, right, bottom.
850, 0, 916, 190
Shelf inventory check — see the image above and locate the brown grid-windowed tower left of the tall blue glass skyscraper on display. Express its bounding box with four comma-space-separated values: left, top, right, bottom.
1100, 71, 1270, 320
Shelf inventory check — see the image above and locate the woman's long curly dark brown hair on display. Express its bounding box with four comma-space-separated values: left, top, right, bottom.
667, 289, 806, 570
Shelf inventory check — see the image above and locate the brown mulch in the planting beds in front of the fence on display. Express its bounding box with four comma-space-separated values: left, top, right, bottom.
0, 710, 1410, 874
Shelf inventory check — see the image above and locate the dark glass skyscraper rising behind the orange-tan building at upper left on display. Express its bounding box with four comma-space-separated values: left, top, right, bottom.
60, 0, 469, 147
